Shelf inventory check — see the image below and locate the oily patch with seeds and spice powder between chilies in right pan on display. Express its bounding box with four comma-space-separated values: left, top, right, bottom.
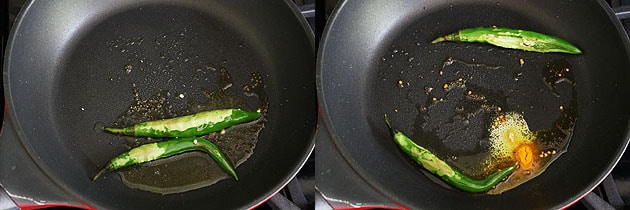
404, 58, 576, 194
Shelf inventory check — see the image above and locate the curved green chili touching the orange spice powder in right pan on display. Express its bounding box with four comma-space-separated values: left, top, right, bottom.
385, 115, 518, 192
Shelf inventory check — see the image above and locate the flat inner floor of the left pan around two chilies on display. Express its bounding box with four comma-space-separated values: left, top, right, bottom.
51, 1, 268, 197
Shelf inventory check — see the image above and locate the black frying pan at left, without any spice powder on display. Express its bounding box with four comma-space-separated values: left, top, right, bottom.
4, 0, 317, 209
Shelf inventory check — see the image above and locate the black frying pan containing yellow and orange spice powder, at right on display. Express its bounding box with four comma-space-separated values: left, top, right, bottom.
317, 0, 630, 209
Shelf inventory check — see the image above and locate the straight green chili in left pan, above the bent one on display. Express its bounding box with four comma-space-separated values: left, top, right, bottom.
105, 109, 261, 138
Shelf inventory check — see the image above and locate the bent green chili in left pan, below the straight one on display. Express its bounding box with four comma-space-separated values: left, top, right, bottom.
92, 137, 238, 181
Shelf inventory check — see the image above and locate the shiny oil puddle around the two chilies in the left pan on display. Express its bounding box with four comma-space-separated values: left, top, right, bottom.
105, 68, 269, 194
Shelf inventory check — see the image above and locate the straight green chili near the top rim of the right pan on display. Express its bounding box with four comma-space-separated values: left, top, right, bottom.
431, 27, 582, 54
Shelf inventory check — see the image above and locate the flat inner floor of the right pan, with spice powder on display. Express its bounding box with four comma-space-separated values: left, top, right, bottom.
376, 6, 577, 194
